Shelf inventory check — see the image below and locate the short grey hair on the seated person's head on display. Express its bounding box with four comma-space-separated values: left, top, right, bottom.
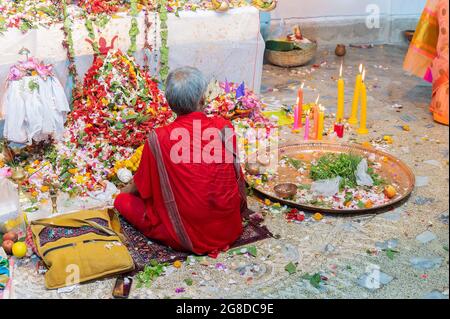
166, 67, 208, 115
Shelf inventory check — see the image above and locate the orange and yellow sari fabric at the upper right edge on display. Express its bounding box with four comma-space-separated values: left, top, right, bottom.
403, 0, 449, 125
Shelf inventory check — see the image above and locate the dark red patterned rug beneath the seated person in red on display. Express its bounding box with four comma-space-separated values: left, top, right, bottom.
120, 217, 272, 270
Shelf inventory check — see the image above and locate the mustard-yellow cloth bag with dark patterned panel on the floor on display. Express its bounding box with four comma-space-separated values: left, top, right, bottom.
30, 209, 134, 289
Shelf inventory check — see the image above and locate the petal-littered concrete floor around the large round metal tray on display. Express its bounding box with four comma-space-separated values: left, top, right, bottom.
14, 46, 449, 299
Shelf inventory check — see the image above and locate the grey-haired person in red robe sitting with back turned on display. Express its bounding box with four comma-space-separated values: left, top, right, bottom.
114, 68, 246, 254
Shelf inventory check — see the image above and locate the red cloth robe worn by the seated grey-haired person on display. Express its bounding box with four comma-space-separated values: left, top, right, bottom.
114, 112, 242, 254
